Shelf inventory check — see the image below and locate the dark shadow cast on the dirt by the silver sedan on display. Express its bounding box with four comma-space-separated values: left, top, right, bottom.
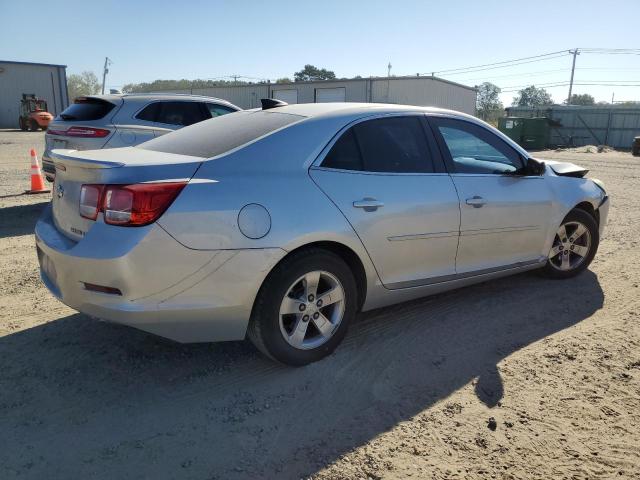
0, 271, 604, 479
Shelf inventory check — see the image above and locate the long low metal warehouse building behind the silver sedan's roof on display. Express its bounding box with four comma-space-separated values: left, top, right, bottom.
161, 77, 476, 115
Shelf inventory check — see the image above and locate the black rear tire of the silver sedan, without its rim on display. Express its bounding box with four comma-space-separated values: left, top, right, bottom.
247, 248, 358, 366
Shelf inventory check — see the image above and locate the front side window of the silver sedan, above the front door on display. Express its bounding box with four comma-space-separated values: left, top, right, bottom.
432, 118, 523, 175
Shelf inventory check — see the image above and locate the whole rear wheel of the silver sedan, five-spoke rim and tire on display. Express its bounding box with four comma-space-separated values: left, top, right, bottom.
247, 248, 358, 366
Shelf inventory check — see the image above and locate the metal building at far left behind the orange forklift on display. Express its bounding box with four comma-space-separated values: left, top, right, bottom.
0, 60, 69, 128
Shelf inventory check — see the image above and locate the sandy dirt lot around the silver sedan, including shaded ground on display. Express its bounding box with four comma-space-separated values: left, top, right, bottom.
0, 131, 640, 480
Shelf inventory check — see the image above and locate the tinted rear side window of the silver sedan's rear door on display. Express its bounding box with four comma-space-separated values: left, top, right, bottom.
322, 116, 434, 173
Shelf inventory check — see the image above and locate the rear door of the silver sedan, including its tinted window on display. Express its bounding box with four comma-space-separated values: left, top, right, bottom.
310, 114, 460, 288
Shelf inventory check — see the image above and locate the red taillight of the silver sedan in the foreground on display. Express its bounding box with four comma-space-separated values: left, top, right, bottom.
80, 182, 187, 227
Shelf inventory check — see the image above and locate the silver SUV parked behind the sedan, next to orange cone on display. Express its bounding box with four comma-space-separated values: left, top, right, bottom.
42, 93, 240, 181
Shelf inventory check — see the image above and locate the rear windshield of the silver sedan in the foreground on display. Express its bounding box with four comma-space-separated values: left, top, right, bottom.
138, 110, 305, 158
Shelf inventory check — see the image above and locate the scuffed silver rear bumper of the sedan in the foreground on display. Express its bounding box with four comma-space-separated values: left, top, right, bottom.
35, 207, 285, 342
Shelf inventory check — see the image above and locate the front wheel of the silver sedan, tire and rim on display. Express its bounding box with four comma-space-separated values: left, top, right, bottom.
543, 209, 600, 279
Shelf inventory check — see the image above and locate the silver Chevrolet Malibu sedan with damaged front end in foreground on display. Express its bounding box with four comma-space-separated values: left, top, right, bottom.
36, 99, 609, 365
